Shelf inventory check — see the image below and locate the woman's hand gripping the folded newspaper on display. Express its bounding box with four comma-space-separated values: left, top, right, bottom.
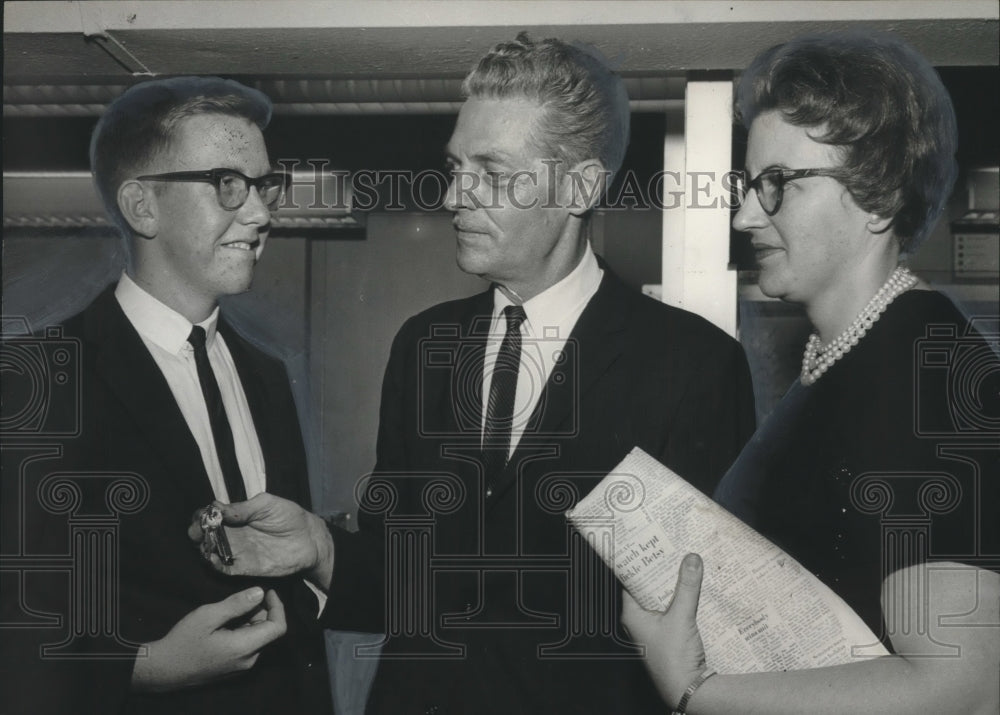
622, 554, 705, 708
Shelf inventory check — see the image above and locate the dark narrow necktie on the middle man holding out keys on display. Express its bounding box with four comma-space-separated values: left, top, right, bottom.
483, 305, 528, 496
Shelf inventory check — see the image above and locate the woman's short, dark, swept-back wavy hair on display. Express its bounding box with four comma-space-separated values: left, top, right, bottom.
734, 31, 958, 251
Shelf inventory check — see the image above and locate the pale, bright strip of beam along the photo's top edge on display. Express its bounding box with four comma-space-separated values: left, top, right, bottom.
4, 0, 1000, 33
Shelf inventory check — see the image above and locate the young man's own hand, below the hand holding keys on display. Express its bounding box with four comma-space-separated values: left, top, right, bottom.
132, 587, 286, 692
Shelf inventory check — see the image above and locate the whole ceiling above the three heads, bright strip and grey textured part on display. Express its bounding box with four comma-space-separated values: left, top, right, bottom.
3, 0, 1000, 104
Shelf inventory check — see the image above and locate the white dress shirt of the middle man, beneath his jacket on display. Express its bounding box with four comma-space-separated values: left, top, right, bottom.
482, 243, 604, 457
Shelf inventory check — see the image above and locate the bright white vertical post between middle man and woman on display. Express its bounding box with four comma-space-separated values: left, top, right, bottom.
663, 81, 737, 336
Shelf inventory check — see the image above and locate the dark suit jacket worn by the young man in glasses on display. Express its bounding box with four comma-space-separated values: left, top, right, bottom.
0, 287, 332, 715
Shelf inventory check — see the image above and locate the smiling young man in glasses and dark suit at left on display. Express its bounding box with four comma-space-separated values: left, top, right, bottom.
0, 77, 331, 715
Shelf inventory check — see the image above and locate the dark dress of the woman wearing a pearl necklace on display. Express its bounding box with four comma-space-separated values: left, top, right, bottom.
715, 290, 1000, 645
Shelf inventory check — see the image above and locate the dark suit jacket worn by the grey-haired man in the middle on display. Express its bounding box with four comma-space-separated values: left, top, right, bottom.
324, 270, 754, 715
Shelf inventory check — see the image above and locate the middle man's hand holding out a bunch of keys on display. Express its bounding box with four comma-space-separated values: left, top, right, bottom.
188, 492, 333, 590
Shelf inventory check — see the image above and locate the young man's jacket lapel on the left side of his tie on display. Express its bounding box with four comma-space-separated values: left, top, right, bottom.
85, 288, 213, 504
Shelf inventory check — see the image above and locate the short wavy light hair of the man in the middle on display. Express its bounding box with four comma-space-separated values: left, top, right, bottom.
462, 32, 629, 180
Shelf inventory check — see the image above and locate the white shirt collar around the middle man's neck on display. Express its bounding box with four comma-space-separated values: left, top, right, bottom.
493, 242, 604, 338
